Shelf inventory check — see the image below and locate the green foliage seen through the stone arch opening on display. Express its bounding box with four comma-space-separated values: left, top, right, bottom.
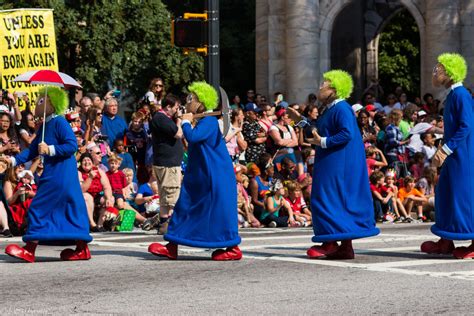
379, 10, 420, 96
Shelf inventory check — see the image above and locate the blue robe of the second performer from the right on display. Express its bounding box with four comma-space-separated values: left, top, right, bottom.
311, 101, 380, 242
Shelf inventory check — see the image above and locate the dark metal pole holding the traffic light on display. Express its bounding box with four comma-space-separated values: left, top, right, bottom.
205, 0, 220, 91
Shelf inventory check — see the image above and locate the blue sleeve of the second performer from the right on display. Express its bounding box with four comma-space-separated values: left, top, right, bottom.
326, 104, 359, 148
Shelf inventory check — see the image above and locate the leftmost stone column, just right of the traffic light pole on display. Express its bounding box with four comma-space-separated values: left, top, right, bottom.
255, 0, 286, 101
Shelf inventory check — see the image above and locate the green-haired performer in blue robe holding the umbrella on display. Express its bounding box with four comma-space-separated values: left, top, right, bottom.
5, 86, 92, 262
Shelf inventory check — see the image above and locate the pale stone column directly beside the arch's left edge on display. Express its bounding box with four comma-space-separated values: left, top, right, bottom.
285, 0, 319, 102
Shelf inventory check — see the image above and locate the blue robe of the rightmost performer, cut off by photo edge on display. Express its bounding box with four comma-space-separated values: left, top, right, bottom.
431, 86, 474, 240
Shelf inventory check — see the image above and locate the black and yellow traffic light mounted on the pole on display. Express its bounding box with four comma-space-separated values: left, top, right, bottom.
171, 13, 208, 55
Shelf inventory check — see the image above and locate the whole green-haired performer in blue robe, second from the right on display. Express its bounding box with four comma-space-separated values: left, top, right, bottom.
307, 70, 380, 259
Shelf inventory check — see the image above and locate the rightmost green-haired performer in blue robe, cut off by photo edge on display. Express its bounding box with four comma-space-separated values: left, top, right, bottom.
421, 53, 474, 259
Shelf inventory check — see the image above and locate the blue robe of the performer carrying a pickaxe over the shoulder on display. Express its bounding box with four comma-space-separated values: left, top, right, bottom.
164, 117, 240, 248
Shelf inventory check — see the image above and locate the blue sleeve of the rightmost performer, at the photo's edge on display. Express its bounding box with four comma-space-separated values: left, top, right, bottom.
446, 91, 473, 152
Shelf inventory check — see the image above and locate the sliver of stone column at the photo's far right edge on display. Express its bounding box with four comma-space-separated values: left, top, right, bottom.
460, 0, 474, 91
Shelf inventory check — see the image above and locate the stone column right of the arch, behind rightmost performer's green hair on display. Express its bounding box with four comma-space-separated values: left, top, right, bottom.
421, 0, 462, 100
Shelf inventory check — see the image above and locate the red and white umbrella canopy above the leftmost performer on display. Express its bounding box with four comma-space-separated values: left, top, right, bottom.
13, 69, 82, 88
